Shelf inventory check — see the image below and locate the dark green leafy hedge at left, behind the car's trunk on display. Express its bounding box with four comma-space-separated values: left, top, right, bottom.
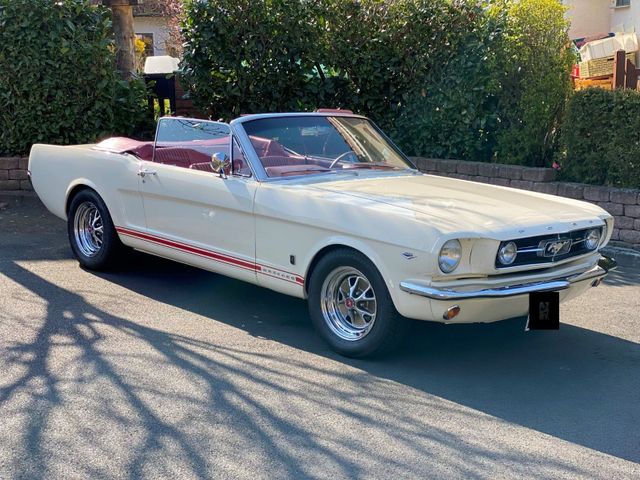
0, 0, 146, 154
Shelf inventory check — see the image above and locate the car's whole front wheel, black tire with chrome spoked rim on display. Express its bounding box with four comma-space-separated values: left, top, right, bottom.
309, 249, 406, 357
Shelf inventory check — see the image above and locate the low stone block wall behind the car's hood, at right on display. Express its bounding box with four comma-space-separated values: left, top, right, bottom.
412, 157, 640, 249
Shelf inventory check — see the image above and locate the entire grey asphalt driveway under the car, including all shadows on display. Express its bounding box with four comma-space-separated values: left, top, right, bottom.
0, 197, 640, 479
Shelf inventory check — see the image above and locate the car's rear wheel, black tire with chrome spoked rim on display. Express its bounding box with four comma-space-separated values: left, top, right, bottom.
67, 189, 126, 270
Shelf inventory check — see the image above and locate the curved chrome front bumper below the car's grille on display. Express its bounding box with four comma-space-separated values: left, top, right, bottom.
400, 256, 617, 300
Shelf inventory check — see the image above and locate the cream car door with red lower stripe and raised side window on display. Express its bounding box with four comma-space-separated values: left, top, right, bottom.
131, 118, 258, 282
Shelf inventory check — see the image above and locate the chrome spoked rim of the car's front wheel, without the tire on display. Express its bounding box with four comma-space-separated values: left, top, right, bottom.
321, 267, 378, 342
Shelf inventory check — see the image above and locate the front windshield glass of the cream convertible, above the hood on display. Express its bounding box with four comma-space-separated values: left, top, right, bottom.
243, 115, 411, 177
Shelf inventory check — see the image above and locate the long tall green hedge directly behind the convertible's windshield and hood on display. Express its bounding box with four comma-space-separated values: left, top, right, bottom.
182, 0, 573, 165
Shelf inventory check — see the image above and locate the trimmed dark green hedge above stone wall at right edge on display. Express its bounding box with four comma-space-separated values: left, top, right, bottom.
560, 88, 640, 188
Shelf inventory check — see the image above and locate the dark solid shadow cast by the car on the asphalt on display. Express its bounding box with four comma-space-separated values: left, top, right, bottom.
95, 255, 640, 462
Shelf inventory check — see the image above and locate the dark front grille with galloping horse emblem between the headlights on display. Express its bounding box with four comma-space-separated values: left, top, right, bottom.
495, 228, 603, 268
